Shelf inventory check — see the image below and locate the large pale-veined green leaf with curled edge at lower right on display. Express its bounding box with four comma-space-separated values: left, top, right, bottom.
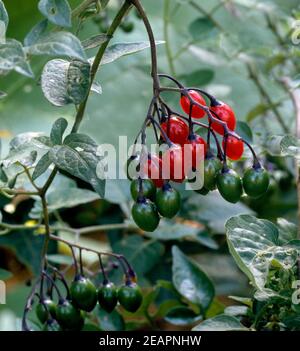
226, 215, 297, 289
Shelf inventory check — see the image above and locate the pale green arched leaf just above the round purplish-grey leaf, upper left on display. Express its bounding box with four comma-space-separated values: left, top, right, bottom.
26, 32, 86, 61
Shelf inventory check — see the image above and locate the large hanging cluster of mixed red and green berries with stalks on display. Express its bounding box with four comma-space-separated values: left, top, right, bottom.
127, 74, 269, 231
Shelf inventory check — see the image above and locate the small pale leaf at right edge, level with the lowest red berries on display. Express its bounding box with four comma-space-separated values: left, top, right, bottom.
266, 135, 300, 158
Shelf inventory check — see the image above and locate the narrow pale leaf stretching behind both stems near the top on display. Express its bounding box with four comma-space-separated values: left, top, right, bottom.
89, 41, 164, 65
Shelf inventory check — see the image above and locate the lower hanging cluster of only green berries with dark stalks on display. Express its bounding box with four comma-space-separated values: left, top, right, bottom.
22, 241, 143, 331
